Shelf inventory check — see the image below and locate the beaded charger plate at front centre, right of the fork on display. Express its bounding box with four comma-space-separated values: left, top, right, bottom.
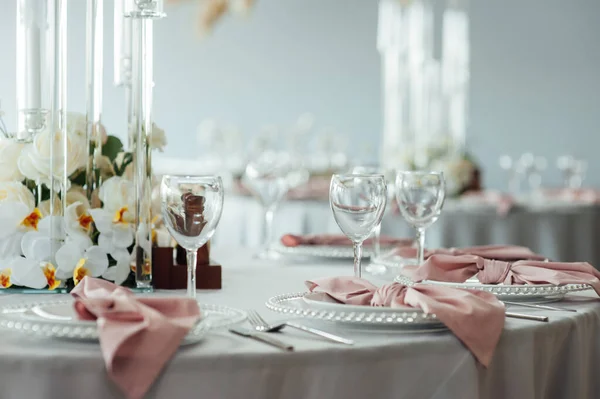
266, 292, 447, 332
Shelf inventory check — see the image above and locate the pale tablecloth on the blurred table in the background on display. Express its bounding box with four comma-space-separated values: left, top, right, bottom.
214, 195, 600, 267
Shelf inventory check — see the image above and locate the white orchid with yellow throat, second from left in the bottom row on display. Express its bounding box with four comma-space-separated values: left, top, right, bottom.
56, 240, 108, 285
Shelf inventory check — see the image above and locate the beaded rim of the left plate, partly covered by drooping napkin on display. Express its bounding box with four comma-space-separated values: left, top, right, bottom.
0, 300, 247, 345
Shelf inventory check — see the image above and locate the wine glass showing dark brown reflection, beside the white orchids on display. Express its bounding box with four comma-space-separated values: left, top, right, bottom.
160, 176, 223, 298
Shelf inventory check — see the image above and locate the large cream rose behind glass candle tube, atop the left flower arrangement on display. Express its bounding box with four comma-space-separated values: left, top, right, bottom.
18, 131, 87, 183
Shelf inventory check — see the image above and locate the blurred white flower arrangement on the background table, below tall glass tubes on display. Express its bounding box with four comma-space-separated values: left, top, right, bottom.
402, 137, 481, 197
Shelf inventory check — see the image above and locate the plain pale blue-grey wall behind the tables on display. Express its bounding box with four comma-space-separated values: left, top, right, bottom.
0, 0, 600, 187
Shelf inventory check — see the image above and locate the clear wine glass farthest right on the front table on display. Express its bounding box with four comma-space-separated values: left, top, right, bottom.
396, 171, 446, 265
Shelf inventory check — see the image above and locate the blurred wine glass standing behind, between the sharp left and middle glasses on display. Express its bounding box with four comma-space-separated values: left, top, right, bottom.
243, 151, 298, 259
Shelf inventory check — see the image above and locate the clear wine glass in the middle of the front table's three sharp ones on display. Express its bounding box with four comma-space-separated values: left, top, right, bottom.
329, 174, 387, 278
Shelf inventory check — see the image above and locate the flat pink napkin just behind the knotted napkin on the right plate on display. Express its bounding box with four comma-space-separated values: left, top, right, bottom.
393, 245, 546, 261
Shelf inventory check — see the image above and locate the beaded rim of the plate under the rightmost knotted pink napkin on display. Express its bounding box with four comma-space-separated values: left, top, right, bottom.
394, 276, 592, 297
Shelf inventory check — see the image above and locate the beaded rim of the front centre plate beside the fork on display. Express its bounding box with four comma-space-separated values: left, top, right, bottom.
265, 292, 441, 326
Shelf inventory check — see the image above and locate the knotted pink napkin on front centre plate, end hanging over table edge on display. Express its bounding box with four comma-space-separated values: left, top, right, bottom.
306, 277, 505, 366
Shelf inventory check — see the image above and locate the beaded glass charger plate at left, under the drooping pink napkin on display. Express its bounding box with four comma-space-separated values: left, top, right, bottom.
0, 299, 247, 345
